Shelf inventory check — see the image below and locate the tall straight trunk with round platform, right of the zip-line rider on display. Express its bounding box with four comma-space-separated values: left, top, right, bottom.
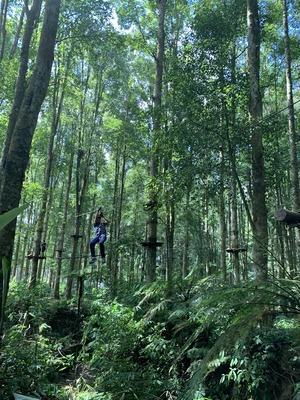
146, 0, 167, 283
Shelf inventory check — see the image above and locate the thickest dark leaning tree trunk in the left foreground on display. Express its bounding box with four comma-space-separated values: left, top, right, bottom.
0, 0, 60, 322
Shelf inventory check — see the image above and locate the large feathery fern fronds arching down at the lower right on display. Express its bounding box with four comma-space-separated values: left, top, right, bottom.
177, 281, 300, 399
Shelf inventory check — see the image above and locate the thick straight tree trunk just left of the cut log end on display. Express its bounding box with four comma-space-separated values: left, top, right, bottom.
247, 0, 268, 281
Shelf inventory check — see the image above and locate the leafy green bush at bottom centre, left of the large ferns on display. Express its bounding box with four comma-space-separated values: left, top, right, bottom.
81, 290, 176, 400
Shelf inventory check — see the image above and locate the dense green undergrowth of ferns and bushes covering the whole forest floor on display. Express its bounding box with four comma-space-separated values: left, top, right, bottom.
0, 276, 300, 400
